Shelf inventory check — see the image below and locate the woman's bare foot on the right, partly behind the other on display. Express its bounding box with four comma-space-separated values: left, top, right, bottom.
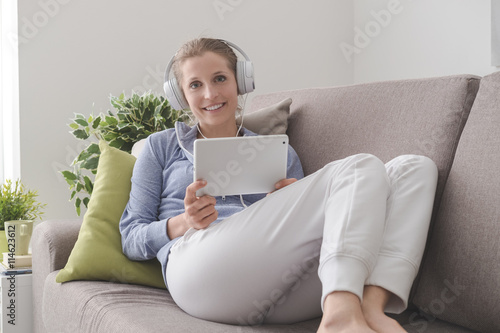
361, 286, 406, 333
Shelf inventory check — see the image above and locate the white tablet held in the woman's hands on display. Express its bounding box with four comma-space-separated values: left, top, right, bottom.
194, 134, 288, 196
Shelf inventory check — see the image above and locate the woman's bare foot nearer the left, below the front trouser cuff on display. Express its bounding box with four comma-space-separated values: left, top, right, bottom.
318, 291, 376, 333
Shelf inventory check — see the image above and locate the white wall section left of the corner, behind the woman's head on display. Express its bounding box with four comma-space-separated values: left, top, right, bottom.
18, 0, 354, 219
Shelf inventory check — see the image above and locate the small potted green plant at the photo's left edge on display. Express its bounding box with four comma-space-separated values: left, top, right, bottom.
0, 179, 45, 253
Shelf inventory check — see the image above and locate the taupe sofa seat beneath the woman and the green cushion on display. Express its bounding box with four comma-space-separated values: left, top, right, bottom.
42, 271, 320, 333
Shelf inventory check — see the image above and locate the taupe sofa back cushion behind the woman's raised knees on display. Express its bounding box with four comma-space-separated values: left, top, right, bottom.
250, 75, 480, 220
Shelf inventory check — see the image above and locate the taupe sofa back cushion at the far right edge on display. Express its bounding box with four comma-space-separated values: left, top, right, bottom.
414, 72, 500, 333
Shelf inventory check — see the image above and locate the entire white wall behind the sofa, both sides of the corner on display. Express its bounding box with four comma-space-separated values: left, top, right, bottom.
18, 0, 497, 218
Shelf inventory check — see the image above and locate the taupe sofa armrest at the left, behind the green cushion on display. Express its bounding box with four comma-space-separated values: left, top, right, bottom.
31, 220, 82, 332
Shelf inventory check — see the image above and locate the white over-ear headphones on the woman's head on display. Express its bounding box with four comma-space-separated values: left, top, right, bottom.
163, 39, 255, 110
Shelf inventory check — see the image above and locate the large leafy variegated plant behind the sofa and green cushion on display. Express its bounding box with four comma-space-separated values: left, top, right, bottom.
61, 92, 187, 215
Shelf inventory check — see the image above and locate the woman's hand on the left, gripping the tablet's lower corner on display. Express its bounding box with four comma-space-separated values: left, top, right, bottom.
167, 180, 219, 239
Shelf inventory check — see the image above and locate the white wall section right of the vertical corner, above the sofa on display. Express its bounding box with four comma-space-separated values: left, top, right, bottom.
353, 0, 500, 83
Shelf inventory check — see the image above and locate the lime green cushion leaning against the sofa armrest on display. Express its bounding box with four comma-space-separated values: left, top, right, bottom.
56, 141, 165, 288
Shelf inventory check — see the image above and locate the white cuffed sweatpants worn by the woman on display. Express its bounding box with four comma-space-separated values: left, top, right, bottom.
166, 154, 437, 325
